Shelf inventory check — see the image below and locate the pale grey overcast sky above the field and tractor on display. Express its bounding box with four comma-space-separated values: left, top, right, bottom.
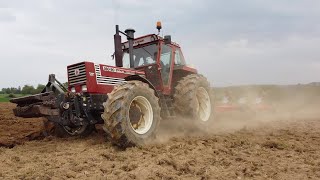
0, 0, 320, 88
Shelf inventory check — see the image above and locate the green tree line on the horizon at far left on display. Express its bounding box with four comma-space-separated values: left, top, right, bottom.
0, 84, 45, 94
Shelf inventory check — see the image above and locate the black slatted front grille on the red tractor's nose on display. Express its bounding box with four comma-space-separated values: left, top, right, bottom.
68, 63, 87, 85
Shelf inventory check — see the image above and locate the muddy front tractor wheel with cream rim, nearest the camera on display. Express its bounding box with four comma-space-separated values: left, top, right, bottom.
101, 81, 160, 148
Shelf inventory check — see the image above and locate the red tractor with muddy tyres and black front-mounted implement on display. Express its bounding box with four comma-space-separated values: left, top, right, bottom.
11, 24, 213, 147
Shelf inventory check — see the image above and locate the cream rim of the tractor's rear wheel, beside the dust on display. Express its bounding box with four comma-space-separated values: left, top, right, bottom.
196, 87, 211, 122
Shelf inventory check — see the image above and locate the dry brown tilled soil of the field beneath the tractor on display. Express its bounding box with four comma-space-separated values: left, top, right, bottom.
0, 103, 320, 179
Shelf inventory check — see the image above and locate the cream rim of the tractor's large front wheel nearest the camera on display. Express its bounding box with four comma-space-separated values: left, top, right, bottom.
128, 96, 153, 134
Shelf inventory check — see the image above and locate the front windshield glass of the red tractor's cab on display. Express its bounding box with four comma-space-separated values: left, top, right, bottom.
122, 44, 158, 68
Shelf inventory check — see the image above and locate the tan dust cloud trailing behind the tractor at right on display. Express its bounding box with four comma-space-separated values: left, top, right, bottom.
158, 86, 320, 143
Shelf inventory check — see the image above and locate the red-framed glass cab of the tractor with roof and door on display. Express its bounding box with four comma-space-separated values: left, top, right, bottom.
122, 34, 197, 95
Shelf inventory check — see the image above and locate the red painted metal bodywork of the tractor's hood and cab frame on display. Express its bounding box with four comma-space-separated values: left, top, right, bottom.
67, 34, 197, 95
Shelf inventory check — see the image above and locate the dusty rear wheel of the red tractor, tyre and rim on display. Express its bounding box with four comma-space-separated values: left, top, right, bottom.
174, 74, 213, 128
